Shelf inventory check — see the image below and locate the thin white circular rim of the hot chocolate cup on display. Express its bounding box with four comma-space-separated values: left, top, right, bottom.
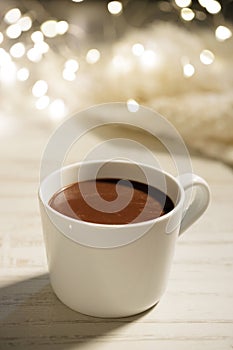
38, 159, 184, 229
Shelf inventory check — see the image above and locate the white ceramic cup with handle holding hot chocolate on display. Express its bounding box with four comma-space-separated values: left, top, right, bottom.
39, 161, 210, 317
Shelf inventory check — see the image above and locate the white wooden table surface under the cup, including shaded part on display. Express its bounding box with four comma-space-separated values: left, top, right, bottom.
0, 118, 233, 350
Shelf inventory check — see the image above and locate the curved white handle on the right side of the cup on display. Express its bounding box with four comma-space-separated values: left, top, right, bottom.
179, 174, 210, 235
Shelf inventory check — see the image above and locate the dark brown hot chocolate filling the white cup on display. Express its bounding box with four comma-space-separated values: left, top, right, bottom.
49, 179, 174, 224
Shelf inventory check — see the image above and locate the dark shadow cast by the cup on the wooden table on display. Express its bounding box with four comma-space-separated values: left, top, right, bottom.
0, 274, 149, 350
